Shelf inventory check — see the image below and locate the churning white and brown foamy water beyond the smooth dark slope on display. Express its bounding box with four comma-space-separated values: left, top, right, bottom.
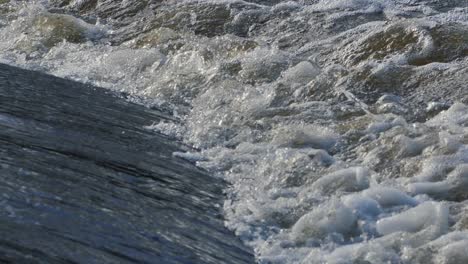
0, 0, 468, 264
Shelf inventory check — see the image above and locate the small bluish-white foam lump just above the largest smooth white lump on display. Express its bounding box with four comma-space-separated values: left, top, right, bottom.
363, 187, 418, 207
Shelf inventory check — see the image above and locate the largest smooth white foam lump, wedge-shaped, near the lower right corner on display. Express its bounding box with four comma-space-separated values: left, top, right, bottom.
377, 202, 449, 235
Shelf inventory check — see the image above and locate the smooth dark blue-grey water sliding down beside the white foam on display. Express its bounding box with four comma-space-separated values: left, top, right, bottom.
0, 65, 253, 263
